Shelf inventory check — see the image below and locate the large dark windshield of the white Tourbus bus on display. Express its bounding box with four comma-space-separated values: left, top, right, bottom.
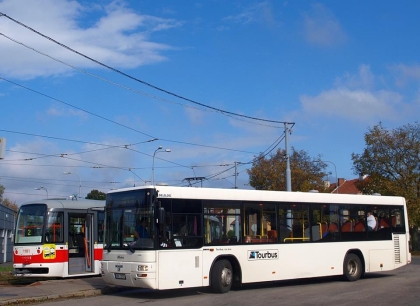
104, 189, 155, 250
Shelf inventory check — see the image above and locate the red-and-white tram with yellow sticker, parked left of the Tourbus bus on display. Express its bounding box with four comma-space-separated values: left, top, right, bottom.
13, 199, 105, 278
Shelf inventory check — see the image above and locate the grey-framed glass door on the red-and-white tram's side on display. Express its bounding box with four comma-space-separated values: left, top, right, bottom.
68, 212, 93, 275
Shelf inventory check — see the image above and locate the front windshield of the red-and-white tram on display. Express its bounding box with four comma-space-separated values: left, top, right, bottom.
14, 204, 47, 245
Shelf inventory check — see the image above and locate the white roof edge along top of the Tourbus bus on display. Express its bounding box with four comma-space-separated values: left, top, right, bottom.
107, 185, 405, 205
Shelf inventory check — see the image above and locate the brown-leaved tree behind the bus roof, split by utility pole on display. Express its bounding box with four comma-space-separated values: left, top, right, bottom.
247, 147, 327, 192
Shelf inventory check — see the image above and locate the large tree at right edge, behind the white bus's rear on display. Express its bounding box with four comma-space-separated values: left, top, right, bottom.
352, 122, 420, 250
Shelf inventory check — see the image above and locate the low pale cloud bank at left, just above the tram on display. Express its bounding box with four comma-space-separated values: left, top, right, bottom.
0, 138, 142, 204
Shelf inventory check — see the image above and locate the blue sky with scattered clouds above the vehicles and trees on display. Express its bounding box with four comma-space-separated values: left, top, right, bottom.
0, 0, 420, 204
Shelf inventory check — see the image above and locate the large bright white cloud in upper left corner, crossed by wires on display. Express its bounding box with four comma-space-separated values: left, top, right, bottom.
0, 0, 181, 79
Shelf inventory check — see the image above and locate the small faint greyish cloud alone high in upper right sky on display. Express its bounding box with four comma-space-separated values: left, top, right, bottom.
303, 3, 347, 46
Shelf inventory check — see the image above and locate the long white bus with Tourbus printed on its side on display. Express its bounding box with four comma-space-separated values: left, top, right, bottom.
101, 186, 411, 293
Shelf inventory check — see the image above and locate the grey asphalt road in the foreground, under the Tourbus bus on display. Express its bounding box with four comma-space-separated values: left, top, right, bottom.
32, 256, 420, 306
